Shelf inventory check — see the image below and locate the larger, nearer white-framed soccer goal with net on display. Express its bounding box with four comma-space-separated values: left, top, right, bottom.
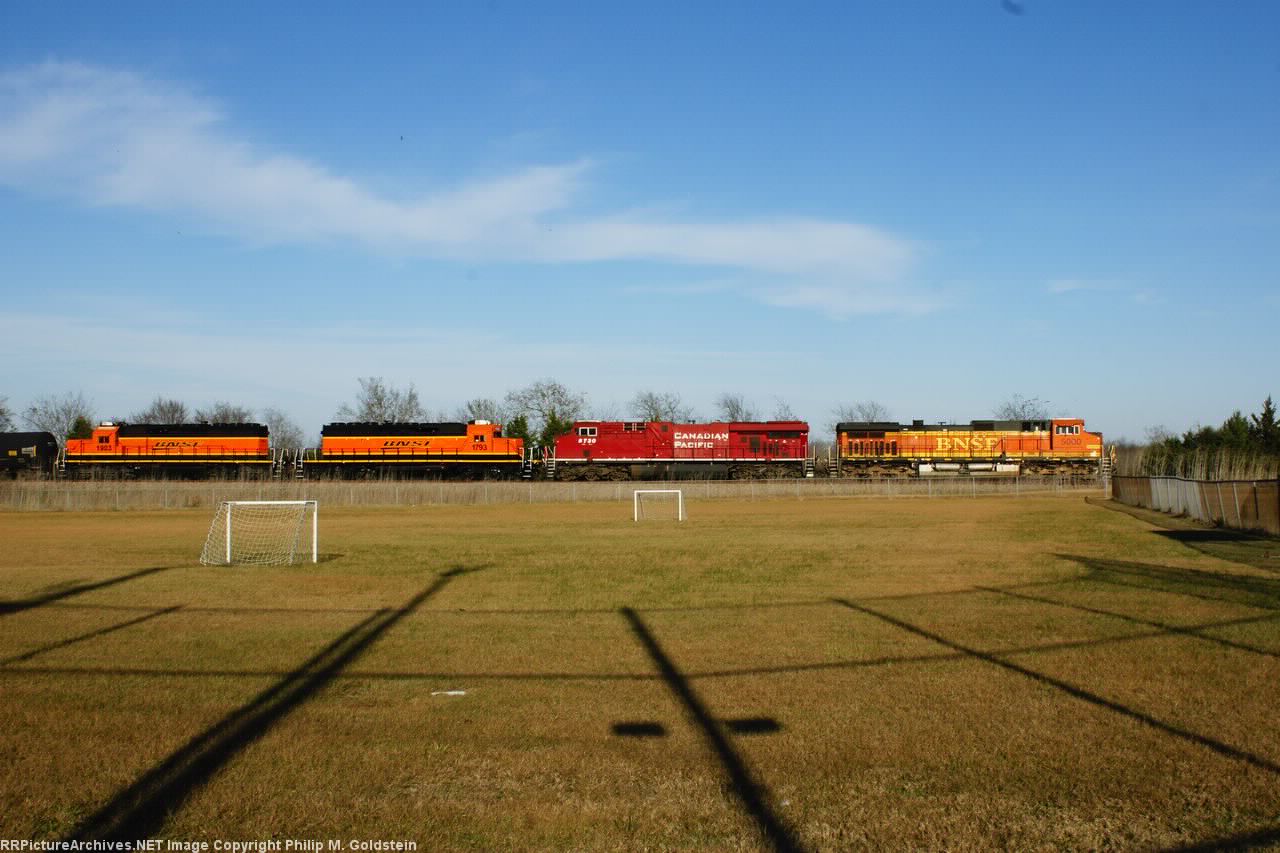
200, 501, 320, 566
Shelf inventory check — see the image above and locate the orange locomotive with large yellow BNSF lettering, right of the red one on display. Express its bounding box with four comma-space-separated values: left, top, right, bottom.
836, 418, 1103, 476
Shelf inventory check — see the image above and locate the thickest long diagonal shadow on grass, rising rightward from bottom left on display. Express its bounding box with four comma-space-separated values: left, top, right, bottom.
68, 567, 480, 840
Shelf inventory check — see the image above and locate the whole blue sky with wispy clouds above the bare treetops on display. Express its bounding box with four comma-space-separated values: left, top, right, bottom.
0, 0, 1280, 439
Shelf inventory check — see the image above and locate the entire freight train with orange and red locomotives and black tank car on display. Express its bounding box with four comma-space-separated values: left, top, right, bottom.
0, 418, 1106, 480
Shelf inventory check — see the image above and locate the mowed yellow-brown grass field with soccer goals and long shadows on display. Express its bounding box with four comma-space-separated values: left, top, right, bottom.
0, 496, 1280, 850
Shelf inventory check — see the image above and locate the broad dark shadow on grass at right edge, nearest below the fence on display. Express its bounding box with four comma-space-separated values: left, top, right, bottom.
1055, 553, 1280, 610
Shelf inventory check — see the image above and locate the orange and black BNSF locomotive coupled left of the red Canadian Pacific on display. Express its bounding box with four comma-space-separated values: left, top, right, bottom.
301, 420, 527, 479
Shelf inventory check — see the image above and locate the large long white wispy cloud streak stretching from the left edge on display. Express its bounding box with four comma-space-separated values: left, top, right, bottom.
0, 63, 929, 315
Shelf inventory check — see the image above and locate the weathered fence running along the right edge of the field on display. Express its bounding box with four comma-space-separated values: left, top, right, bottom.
1111, 476, 1280, 535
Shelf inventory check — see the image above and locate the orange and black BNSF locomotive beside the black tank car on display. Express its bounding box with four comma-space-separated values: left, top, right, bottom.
61, 421, 276, 478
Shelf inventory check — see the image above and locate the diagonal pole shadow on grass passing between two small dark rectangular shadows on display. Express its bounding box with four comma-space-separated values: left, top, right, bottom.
616, 607, 804, 852
